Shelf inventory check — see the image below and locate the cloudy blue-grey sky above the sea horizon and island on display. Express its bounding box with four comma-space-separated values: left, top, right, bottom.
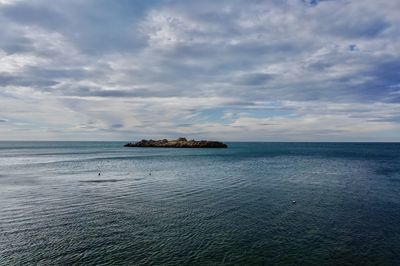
0, 0, 400, 141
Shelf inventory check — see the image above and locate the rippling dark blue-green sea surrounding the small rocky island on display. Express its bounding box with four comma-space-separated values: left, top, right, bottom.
0, 142, 400, 265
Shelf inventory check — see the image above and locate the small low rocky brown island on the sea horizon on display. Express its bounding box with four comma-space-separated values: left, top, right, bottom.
124, 138, 228, 148
